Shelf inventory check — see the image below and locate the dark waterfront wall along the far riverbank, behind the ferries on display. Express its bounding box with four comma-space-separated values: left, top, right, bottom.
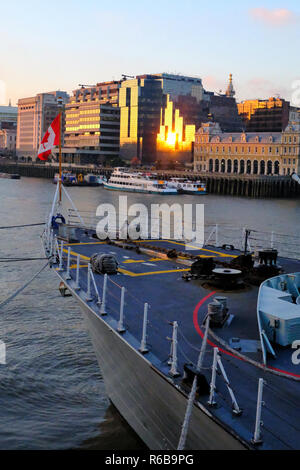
0, 163, 300, 198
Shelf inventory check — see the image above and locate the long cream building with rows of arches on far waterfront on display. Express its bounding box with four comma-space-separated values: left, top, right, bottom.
194, 122, 300, 175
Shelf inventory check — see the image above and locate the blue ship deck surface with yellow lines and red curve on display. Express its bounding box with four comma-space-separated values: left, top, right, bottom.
55, 230, 300, 449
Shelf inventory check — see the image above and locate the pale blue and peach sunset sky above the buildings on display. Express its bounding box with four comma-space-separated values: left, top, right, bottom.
0, 0, 300, 106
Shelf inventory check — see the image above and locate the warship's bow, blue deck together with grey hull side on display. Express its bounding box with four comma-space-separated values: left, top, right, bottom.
44, 227, 300, 450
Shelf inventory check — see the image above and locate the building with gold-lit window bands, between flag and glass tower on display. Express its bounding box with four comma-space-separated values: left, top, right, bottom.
61, 81, 121, 164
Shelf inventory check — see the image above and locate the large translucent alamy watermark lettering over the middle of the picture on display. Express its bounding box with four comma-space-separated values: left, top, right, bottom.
96, 196, 204, 250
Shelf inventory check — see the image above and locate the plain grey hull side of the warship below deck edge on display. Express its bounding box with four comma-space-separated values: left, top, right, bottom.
71, 291, 247, 450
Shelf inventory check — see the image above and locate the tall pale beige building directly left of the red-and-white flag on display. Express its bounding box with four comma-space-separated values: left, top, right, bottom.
17, 91, 69, 160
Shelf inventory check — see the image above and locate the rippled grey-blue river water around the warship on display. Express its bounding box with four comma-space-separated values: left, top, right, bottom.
0, 178, 300, 450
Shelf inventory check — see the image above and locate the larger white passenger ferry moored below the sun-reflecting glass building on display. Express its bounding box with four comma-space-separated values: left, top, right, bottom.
104, 167, 178, 195
